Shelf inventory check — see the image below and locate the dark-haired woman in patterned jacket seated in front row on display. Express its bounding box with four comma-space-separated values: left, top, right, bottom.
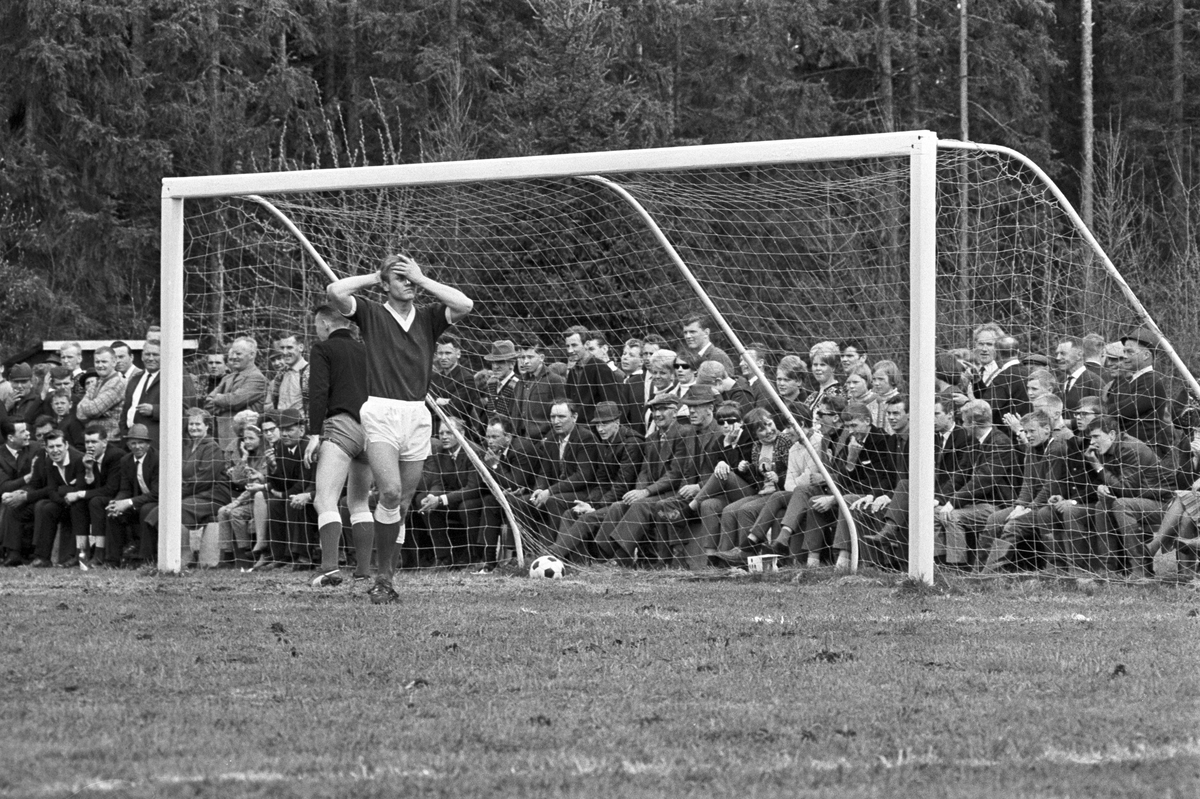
716, 408, 803, 566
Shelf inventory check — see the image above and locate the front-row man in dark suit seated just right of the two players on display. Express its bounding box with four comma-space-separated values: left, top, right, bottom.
416, 416, 484, 566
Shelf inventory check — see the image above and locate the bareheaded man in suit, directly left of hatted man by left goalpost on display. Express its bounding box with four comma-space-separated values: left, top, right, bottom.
65, 423, 126, 565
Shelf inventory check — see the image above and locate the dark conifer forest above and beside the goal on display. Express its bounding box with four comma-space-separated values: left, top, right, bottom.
0, 0, 1200, 356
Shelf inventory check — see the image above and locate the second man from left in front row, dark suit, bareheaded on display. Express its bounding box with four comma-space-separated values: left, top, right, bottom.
29, 429, 83, 569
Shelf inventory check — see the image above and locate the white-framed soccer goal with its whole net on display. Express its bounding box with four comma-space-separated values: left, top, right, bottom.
163, 134, 1186, 578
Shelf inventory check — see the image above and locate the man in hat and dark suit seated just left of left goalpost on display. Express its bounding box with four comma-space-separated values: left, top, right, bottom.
104, 425, 158, 566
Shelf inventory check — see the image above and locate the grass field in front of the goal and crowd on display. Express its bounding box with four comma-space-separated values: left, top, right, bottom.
0, 569, 1200, 798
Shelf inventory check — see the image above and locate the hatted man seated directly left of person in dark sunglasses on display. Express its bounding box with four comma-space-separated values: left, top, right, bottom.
597, 385, 721, 560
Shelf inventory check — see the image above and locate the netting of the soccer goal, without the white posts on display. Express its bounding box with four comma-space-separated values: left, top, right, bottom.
185, 144, 1194, 572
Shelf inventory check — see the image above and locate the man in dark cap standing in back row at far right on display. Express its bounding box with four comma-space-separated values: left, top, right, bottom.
1108, 326, 1175, 457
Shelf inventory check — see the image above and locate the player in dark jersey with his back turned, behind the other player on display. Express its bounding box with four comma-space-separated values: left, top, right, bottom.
304, 305, 374, 588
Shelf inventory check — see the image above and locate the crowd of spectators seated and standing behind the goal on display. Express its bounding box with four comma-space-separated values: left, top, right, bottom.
0, 317, 1200, 578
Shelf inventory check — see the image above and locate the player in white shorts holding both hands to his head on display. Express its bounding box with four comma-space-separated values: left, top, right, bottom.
328, 254, 474, 605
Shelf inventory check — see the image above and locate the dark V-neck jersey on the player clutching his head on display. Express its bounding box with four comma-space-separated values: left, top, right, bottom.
348, 298, 450, 402
